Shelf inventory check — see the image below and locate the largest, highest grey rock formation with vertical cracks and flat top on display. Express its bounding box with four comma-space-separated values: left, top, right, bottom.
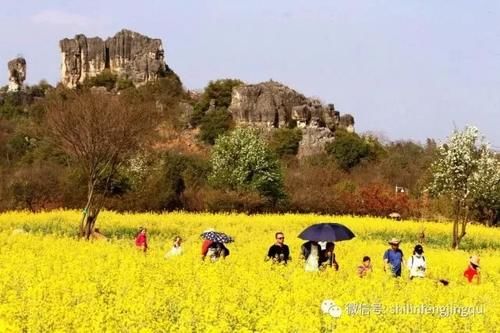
59, 29, 171, 88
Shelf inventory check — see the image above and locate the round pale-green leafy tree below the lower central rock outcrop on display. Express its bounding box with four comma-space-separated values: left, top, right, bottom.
209, 128, 284, 203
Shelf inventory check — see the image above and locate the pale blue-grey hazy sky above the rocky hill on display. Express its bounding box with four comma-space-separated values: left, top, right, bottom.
0, 0, 500, 150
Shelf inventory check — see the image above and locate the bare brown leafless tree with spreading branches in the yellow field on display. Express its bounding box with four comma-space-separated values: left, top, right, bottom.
45, 91, 157, 239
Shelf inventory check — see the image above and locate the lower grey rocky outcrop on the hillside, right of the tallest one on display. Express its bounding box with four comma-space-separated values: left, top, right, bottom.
229, 81, 354, 156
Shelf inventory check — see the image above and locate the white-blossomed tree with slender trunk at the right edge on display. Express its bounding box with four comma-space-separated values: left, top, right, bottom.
427, 126, 499, 248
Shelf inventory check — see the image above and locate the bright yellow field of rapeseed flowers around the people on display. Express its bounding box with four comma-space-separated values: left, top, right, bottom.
0, 211, 500, 333
